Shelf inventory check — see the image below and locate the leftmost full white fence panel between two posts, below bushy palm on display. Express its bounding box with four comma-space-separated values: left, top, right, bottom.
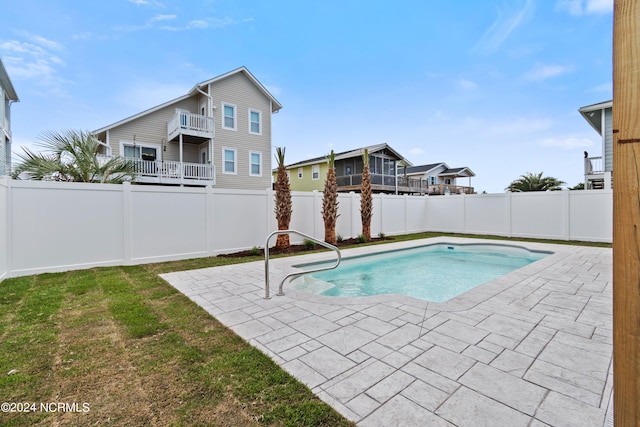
10, 181, 125, 275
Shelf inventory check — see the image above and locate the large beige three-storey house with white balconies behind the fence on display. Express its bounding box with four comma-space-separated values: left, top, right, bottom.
93, 67, 282, 190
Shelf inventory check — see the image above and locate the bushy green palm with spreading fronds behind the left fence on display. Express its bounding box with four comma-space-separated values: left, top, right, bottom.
13, 129, 136, 184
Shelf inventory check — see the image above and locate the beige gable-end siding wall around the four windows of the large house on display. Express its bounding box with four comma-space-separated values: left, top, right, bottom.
209, 73, 271, 190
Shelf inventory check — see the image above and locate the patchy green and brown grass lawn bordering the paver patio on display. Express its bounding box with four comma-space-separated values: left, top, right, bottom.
0, 233, 611, 426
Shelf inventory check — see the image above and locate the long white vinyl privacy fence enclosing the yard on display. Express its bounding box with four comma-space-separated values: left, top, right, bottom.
0, 177, 613, 280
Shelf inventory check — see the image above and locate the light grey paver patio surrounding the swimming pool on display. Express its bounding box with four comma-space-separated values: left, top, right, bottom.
162, 237, 613, 427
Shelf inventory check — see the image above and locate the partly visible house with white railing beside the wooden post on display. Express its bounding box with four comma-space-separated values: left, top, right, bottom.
578, 101, 613, 190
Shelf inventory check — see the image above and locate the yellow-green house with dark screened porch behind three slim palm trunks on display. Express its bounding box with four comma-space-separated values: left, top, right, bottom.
273, 144, 413, 194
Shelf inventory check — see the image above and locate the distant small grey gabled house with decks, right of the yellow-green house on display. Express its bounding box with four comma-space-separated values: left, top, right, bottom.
398, 162, 476, 195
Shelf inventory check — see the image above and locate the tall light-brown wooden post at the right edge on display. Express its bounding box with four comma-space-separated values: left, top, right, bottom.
613, 0, 640, 426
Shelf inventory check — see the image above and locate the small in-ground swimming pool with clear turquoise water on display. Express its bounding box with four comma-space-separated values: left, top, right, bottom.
293, 243, 551, 302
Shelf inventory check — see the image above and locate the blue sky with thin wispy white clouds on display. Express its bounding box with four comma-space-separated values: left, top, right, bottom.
0, 0, 613, 193
